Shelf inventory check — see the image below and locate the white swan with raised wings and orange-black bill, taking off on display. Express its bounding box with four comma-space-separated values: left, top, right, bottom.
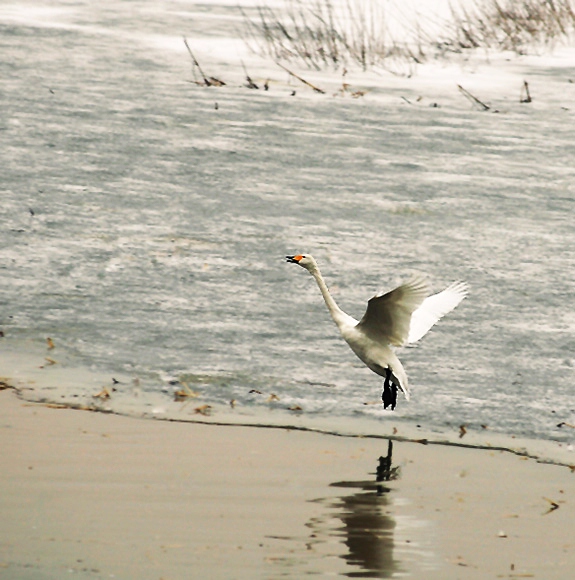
286, 254, 468, 410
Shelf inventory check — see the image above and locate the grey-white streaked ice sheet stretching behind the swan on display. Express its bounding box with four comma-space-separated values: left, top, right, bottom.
0, 1, 575, 462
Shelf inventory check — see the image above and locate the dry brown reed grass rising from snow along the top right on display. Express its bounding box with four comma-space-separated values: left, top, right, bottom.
243, 0, 575, 71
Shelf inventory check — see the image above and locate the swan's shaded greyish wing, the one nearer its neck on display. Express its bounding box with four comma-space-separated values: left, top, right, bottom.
357, 278, 429, 346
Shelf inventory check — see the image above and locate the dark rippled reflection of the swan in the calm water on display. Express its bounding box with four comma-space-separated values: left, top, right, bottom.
309, 441, 400, 578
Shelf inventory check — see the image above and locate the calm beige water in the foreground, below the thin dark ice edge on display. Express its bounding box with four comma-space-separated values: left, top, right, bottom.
0, 390, 575, 580
